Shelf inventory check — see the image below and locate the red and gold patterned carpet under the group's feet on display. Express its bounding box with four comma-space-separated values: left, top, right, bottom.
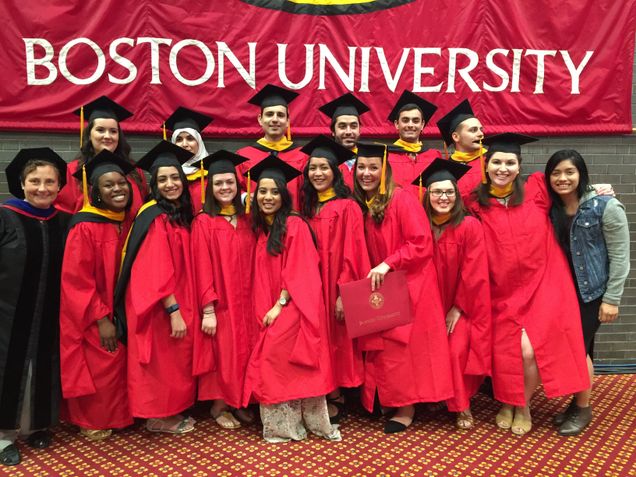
0, 375, 636, 477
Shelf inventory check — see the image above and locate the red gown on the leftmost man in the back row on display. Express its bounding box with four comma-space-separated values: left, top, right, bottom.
236, 143, 307, 210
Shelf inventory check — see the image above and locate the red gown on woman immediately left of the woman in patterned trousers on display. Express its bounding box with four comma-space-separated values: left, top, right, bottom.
192, 214, 258, 407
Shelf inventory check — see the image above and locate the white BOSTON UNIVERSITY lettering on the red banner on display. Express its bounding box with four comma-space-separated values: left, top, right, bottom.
23, 37, 594, 95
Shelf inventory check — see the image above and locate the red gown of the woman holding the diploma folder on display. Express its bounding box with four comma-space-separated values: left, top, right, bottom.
360, 187, 453, 411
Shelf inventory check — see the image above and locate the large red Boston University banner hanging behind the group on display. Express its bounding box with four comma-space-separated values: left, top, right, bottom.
0, 0, 636, 137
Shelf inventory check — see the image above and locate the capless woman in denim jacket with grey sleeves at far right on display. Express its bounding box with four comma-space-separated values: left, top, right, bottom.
545, 150, 629, 436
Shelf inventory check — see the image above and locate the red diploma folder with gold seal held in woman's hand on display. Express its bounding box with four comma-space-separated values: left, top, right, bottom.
340, 270, 411, 338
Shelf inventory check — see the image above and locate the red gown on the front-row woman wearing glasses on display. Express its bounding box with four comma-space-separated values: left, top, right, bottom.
435, 217, 492, 412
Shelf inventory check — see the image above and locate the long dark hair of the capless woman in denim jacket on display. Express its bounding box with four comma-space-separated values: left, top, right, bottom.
545, 149, 590, 248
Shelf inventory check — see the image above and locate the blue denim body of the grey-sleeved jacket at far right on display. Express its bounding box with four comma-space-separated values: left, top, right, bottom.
570, 192, 611, 303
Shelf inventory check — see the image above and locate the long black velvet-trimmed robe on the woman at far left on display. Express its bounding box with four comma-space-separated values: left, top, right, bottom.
0, 206, 69, 431
